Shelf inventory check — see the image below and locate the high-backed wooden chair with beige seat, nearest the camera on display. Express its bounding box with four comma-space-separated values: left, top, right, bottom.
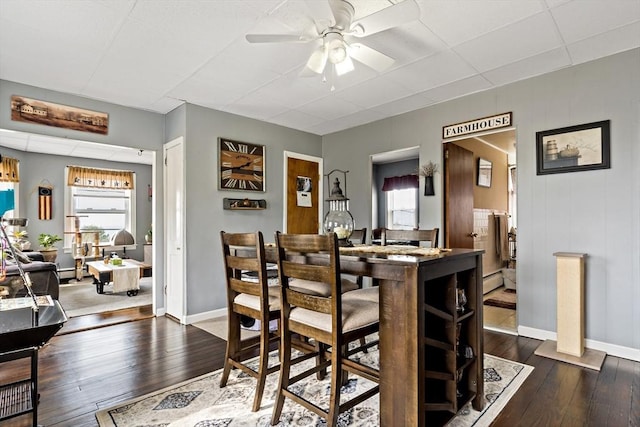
271, 232, 379, 426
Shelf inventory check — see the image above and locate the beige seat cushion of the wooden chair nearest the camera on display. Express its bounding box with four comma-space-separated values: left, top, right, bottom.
289, 291, 380, 332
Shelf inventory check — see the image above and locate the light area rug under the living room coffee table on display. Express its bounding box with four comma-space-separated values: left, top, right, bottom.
58, 277, 153, 317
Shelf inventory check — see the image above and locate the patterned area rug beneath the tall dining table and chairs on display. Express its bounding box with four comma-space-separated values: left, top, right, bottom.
96, 348, 533, 427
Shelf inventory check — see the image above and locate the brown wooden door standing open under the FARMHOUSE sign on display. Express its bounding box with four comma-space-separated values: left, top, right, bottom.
444, 143, 474, 249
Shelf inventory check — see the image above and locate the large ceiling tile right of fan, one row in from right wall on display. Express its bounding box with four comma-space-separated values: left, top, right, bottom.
454, 12, 562, 72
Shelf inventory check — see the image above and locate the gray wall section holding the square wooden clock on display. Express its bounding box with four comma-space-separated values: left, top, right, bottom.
180, 104, 322, 315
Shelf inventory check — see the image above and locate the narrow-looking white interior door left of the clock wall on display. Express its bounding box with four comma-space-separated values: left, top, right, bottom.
164, 137, 186, 323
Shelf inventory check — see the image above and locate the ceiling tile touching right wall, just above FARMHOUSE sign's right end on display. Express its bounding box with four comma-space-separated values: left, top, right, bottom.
482, 47, 571, 86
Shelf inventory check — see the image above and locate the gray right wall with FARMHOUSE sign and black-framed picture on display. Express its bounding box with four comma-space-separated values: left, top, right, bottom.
323, 49, 640, 359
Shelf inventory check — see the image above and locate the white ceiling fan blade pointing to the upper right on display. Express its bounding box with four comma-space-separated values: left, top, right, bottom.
350, 0, 420, 37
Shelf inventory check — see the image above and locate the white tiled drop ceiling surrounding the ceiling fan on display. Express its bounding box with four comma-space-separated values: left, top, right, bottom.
0, 0, 640, 143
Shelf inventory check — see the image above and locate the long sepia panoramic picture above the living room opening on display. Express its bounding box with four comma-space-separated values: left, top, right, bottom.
11, 95, 109, 135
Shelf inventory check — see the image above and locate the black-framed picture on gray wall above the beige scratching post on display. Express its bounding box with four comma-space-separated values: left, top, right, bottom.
536, 120, 611, 175
